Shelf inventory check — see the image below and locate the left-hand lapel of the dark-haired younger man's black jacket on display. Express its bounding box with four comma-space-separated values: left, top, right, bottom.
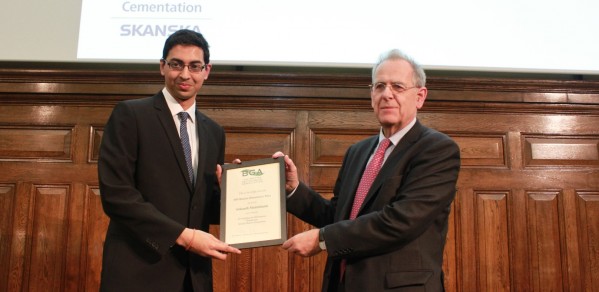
154, 92, 191, 190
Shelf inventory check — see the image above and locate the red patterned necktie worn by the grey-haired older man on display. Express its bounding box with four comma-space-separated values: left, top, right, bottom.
339, 139, 391, 281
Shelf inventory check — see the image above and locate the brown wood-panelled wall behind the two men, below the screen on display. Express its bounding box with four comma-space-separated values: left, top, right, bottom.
0, 69, 599, 291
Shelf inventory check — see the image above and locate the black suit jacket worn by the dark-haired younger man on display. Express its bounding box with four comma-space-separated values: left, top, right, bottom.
98, 92, 225, 291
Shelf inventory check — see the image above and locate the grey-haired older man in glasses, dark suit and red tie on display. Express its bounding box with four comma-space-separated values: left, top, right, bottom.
273, 50, 460, 292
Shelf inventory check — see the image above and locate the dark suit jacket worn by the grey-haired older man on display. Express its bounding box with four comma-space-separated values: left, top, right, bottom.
287, 122, 460, 292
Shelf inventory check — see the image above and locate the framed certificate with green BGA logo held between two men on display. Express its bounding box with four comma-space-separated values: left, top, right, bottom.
220, 157, 287, 248
